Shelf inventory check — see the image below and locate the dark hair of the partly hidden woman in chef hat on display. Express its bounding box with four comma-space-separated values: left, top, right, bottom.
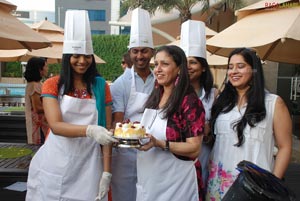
195, 57, 214, 100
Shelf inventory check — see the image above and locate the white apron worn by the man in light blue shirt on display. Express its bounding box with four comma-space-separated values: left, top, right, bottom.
112, 68, 149, 201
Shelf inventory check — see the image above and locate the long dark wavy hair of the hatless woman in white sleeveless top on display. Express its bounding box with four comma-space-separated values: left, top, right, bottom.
211, 48, 266, 147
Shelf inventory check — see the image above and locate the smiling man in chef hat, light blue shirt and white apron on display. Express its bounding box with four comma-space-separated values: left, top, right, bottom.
111, 8, 154, 201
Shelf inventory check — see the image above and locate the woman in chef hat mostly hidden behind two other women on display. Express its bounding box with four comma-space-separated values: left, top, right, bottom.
180, 20, 218, 196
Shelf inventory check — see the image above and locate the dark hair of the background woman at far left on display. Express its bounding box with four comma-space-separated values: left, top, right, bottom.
24, 57, 46, 82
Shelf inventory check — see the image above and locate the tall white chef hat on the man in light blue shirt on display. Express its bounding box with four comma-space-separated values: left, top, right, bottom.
128, 8, 153, 48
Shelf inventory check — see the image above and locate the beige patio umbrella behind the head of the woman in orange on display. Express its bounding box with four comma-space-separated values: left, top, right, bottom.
0, 20, 105, 64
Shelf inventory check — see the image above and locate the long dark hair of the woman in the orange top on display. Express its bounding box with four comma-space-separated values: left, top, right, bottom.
58, 54, 99, 95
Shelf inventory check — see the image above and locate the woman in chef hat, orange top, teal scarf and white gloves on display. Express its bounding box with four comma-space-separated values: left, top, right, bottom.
26, 10, 116, 201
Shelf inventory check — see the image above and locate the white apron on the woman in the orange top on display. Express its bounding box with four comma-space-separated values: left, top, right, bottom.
26, 95, 107, 201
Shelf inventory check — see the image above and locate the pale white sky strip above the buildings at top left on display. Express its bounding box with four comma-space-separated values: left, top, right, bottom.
6, 0, 55, 12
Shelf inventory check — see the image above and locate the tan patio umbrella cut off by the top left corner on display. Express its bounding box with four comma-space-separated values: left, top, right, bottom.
0, 0, 51, 50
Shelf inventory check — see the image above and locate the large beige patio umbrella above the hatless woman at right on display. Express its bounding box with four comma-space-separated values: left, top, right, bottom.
207, 0, 300, 64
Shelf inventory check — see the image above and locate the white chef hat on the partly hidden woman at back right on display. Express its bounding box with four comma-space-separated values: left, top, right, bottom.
180, 20, 206, 59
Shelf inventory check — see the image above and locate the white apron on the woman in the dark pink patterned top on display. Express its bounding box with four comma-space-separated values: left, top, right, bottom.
136, 109, 199, 201
